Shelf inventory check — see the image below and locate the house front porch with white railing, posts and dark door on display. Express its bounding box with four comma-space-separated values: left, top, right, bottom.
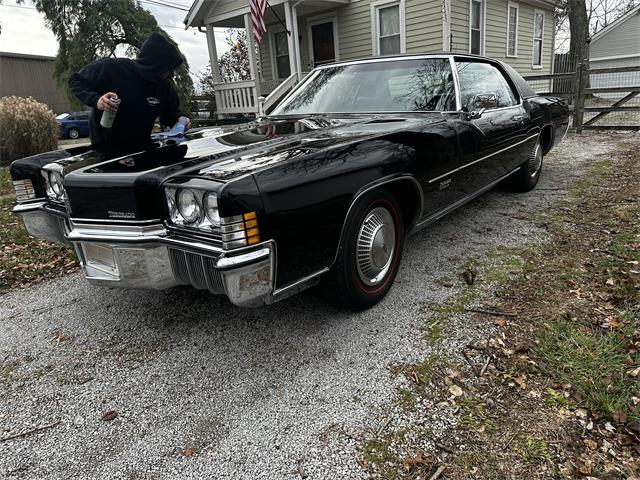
185, 0, 349, 116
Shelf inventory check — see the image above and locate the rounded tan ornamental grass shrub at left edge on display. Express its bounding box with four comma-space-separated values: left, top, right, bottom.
0, 96, 58, 165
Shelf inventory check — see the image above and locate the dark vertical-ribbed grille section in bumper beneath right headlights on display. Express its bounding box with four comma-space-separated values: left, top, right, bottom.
169, 248, 224, 294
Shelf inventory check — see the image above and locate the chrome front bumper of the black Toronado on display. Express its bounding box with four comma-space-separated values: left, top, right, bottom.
14, 203, 276, 307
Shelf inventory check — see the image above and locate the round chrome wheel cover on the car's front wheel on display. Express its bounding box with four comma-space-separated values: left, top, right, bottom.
356, 207, 396, 287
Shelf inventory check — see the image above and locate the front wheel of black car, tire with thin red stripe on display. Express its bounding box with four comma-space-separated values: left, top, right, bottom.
332, 190, 405, 310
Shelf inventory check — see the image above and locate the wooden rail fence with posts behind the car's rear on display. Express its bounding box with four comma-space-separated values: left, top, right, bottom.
525, 62, 640, 133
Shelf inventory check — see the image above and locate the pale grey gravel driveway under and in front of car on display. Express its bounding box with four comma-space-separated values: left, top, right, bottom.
0, 135, 616, 479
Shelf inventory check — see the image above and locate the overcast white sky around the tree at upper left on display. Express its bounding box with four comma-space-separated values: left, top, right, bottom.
0, 0, 227, 84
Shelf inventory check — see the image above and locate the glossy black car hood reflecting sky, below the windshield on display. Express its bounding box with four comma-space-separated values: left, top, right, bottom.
65, 113, 443, 181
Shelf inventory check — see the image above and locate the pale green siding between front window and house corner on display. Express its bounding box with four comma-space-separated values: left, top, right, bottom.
405, 0, 442, 53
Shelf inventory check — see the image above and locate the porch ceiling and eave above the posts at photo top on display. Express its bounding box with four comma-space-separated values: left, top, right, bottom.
184, 0, 352, 28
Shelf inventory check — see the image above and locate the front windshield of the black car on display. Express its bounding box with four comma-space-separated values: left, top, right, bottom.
271, 58, 456, 115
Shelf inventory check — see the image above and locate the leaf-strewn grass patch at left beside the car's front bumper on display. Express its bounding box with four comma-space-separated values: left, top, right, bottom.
0, 198, 78, 292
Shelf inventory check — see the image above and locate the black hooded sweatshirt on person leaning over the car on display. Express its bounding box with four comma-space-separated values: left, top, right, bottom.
69, 33, 182, 152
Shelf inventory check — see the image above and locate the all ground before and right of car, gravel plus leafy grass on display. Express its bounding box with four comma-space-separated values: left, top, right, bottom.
0, 133, 640, 480
